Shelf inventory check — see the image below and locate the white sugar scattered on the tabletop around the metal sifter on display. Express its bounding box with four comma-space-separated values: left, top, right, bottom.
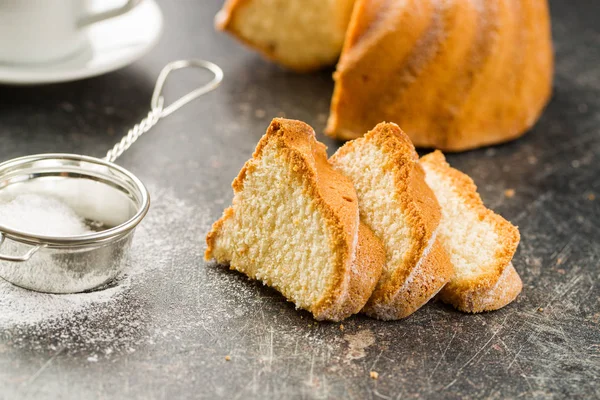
0, 185, 213, 354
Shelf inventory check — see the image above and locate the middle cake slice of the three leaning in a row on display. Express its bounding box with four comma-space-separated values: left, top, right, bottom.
330, 123, 452, 320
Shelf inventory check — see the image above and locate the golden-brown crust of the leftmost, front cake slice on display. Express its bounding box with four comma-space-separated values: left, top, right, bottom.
205, 118, 385, 321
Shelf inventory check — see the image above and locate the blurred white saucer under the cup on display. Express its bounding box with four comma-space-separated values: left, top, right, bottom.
0, 0, 163, 85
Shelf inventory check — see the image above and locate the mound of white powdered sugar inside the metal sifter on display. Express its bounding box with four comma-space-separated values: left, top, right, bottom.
0, 194, 92, 237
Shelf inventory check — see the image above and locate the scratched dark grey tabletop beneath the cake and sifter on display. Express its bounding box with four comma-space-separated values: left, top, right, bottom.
0, 0, 600, 399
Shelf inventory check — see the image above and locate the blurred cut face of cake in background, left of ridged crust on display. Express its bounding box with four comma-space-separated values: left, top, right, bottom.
215, 0, 354, 72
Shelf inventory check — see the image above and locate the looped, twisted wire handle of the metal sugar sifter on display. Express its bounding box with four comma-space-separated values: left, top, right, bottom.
104, 60, 223, 162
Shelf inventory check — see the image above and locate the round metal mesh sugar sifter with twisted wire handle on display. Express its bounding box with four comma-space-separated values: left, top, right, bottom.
0, 60, 223, 293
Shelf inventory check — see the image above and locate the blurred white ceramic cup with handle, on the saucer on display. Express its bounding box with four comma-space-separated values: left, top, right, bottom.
0, 0, 141, 64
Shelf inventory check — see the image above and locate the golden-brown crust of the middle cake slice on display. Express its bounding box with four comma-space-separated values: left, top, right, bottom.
332, 123, 453, 320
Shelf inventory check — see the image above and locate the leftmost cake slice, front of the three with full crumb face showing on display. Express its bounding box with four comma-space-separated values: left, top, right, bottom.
205, 118, 385, 321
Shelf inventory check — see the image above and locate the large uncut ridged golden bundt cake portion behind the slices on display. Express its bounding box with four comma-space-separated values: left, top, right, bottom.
326, 0, 553, 151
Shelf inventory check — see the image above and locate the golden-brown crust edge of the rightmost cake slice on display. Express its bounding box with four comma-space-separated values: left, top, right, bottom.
421, 151, 523, 313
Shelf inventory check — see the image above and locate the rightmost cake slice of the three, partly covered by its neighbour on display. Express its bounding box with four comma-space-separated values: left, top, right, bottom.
421, 151, 523, 313
